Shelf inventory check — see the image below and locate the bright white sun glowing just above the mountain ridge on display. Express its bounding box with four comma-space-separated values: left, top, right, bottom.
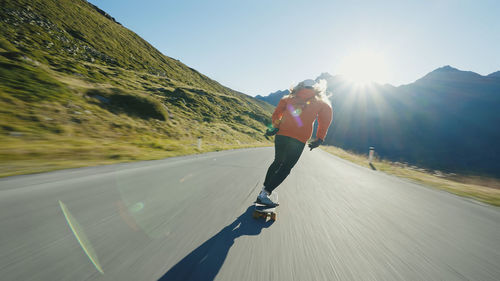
338, 50, 391, 85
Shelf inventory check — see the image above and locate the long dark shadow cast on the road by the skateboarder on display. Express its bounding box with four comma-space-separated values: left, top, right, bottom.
159, 203, 273, 281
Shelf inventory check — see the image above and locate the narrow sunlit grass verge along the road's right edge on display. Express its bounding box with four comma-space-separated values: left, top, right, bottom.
321, 146, 500, 206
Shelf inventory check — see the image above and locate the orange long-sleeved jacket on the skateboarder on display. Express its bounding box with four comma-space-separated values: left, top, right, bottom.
272, 89, 333, 143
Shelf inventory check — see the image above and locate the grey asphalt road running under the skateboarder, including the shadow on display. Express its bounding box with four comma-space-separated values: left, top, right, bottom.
0, 148, 500, 281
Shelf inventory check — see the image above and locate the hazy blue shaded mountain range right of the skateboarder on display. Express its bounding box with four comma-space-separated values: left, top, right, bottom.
256, 66, 500, 177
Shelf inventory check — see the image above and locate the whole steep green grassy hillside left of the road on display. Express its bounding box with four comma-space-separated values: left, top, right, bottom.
0, 0, 272, 176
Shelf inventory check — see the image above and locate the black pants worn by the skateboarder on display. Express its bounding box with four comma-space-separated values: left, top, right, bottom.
264, 135, 305, 193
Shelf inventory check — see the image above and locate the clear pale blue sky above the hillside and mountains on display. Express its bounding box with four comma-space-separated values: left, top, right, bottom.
89, 0, 500, 96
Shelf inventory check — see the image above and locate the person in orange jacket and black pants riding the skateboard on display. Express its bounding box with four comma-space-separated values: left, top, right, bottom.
256, 79, 333, 206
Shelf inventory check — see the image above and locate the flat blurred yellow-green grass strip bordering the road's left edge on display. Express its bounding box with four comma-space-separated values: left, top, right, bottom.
0, 137, 269, 177
